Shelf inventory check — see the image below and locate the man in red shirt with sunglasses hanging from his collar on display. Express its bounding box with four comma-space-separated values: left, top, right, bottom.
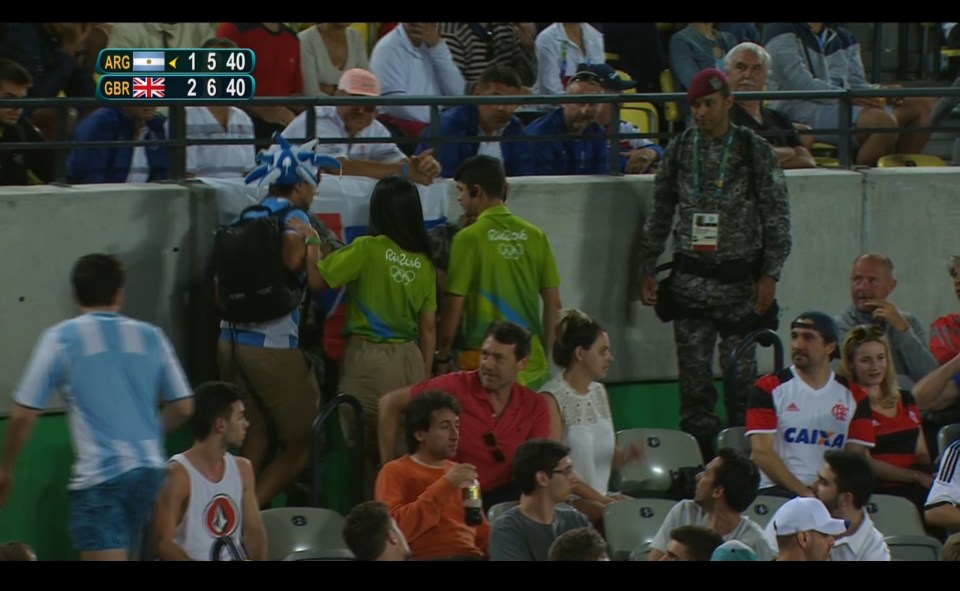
378, 322, 552, 512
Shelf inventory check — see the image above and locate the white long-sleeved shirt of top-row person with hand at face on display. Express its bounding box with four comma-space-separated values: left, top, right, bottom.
370, 24, 466, 123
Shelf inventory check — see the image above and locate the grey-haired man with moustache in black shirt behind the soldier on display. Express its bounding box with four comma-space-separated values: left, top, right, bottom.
723, 42, 817, 169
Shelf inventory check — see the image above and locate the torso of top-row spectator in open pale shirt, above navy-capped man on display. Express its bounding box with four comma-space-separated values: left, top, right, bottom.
534, 23, 606, 98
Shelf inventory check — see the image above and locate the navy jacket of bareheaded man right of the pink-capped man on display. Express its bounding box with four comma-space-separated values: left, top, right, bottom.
417, 105, 533, 178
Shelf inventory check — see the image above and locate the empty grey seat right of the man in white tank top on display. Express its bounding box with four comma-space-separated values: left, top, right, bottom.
260, 507, 349, 560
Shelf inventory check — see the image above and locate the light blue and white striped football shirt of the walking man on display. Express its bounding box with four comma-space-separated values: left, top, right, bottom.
13, 312, 193, 490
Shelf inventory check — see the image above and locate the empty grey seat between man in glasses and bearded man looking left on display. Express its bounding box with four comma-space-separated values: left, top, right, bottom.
603, 499, 676, 560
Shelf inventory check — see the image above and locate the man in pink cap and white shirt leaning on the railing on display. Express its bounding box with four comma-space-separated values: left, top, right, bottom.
283, 68, 440, 185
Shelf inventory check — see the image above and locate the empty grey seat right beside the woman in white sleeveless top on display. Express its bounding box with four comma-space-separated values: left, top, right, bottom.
617, 428, 703, 498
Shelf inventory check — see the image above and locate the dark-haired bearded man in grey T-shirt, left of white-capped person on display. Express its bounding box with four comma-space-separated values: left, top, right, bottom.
631, 447, 776, 561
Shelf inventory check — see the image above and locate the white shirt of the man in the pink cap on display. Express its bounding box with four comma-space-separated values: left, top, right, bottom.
284, 106, 407, 162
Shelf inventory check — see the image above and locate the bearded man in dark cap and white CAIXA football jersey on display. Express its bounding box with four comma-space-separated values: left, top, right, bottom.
746, 311, 875, 497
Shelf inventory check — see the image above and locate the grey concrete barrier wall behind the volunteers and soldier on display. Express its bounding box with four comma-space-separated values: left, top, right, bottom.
0, 168, 960, 413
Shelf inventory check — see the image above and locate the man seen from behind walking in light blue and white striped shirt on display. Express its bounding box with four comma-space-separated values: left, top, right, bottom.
0, 254, 193, 560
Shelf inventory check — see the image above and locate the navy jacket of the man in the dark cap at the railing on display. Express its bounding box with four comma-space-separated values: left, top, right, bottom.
527, 107, 610, 175
